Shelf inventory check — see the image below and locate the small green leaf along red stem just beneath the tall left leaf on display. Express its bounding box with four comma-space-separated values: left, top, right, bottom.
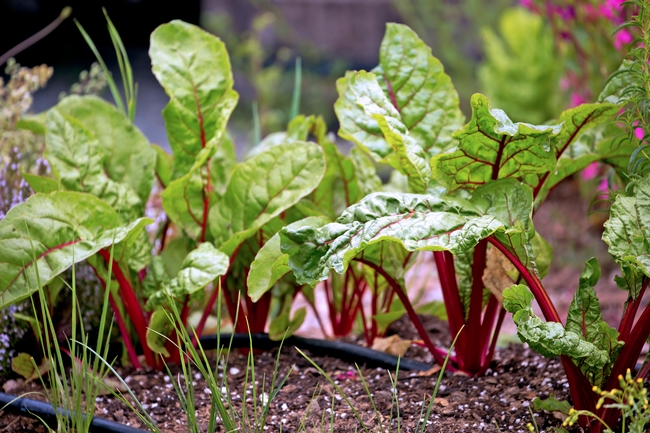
161, 146, 217, 242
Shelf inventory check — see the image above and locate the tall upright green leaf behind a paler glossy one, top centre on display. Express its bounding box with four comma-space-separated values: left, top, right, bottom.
372, 23, 465, 156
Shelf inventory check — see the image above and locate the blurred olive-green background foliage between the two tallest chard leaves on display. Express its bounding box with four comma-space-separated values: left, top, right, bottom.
201, 8, 346, 145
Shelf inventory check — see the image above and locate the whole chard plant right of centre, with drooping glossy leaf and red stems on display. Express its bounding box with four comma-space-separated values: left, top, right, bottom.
280, 24, 632, 382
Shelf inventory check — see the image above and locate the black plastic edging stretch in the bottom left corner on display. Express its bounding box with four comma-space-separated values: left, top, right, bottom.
0, 392, 148, 433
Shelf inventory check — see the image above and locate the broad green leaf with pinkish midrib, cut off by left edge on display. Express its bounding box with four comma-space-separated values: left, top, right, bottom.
0, 191, 152, 308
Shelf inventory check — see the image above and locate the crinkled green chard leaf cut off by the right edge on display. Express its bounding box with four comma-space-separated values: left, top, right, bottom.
603, 176, 650, 276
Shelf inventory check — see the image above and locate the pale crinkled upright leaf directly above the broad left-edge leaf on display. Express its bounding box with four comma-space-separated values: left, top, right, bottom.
45, 109, 143, 221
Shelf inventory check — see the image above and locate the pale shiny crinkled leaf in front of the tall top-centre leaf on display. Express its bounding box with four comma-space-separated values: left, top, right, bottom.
335, 71, 431, 192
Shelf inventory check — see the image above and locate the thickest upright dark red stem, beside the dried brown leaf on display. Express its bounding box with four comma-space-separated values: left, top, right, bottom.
458, 239, 491, 374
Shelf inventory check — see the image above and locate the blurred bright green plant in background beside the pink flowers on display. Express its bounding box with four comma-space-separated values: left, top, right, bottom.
478, 8, 566, 123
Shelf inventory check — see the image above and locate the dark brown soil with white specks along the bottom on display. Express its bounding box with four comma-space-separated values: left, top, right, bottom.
0, 319, 568, 433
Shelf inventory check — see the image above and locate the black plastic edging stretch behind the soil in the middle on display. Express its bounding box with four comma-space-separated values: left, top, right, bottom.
195, 333, 433, 371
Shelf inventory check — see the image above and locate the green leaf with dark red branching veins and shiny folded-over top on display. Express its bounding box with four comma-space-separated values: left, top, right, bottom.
431, 94, 562, 190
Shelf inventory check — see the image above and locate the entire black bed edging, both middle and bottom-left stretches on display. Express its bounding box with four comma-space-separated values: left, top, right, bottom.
0, 334, 431, 433
